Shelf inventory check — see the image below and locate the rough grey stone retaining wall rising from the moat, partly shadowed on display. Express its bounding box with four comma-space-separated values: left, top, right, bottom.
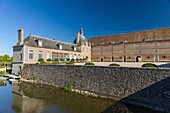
21, 65, 170, 111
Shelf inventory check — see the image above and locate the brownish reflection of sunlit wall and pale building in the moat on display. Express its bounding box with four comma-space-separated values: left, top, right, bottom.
13, 82, 114, 113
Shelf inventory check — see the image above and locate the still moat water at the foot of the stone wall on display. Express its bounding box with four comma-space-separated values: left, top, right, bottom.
0, 82, 162, 113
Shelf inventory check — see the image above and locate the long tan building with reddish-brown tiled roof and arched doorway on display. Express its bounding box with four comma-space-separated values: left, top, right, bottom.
89, 28, 170, 62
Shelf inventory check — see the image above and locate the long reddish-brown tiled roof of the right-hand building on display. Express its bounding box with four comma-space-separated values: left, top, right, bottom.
89, 28, 170, 45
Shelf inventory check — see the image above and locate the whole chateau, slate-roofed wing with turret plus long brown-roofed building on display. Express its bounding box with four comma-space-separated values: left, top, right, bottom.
13, 28, 170, 74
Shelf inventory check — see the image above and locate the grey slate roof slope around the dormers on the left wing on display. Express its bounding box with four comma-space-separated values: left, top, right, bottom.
18, 35, 81, 52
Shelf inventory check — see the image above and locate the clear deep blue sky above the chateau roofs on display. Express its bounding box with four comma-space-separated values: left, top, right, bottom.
0, 0, 170, 55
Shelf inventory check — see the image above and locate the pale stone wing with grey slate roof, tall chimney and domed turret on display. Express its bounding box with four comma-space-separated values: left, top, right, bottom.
12, 28, 91, 74
